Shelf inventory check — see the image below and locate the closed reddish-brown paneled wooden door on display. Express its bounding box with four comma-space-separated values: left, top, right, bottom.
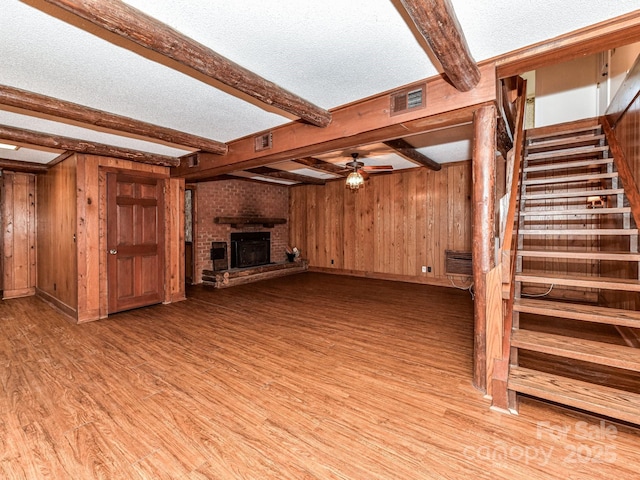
107, 173, 164, 313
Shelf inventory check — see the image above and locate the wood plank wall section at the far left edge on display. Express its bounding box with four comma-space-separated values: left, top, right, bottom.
2, 172, 36, 299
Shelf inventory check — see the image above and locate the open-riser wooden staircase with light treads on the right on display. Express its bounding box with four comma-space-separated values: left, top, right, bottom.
507, 121, 640, 425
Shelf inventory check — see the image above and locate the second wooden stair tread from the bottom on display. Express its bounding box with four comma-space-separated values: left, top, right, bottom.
511, 330, 640, 371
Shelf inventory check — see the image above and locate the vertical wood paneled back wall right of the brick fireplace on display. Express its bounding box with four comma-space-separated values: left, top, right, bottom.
289, 165, 471, 286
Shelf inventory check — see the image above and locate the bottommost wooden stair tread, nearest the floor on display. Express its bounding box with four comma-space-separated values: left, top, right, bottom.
508, 367, 640, 424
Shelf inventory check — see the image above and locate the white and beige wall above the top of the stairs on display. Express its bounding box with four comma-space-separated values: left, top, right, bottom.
535, 55, 598, 127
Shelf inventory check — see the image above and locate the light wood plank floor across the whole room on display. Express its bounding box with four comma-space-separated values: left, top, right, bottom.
0, 273, 640, 480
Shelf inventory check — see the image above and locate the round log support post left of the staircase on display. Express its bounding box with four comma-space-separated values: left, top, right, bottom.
472, 105, 497, 392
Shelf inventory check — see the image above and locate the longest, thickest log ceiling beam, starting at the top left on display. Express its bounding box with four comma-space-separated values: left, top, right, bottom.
44, 0, 331, 127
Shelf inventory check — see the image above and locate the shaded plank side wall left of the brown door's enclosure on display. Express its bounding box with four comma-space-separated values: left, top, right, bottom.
37, 156, 78, 315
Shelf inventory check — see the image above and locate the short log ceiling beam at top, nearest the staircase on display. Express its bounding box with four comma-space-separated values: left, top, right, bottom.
400, 0, 480, 92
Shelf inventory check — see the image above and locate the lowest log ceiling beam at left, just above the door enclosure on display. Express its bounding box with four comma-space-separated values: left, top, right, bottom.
0, 125, 180, 167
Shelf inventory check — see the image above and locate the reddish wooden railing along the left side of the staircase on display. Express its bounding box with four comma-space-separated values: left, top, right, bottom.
489, 81, 527, 411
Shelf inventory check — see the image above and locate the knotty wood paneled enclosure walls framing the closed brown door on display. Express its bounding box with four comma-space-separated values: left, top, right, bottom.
38, 154, 184, 323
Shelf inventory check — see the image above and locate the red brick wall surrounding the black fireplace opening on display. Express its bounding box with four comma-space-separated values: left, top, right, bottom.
194, 180, 289, 283
